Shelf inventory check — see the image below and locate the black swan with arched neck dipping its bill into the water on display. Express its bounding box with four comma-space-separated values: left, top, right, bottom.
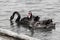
10, 11, 39, 25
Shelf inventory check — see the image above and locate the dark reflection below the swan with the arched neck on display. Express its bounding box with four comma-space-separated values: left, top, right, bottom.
10, 21, 34, 36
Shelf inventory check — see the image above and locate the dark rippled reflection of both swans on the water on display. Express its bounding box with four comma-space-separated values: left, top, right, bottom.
10, 21, 55, 37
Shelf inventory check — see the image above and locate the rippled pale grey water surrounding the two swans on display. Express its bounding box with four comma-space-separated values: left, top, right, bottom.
0, 0, 60, 40
